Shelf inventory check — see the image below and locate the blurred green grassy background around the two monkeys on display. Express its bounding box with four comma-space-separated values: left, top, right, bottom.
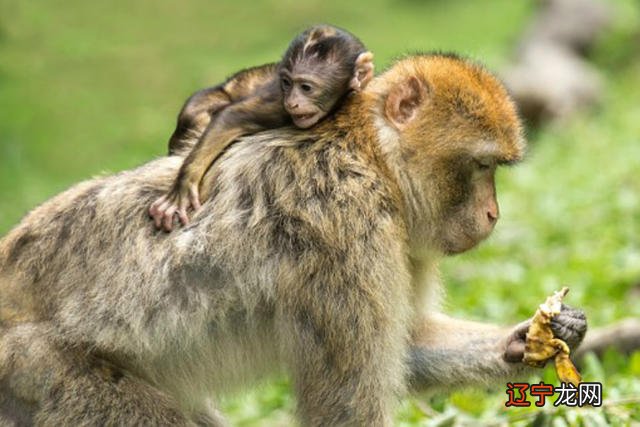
0, 0, 640, 426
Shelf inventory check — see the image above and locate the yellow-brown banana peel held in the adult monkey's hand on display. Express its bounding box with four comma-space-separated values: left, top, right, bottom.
523, 287, 582, 387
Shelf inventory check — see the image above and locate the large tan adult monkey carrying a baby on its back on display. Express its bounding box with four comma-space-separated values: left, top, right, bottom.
0, 55, 586, 426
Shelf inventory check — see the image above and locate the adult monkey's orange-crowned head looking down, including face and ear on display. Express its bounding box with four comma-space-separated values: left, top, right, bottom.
372, 54, 524, 255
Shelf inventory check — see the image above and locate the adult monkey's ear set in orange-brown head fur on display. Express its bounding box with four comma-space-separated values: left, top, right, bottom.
384, 76, 427, 130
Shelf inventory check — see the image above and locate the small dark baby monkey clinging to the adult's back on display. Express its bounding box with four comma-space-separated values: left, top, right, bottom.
149, 25, 373, 231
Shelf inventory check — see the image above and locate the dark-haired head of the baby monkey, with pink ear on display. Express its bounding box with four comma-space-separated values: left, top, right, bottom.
280, 25, 373, 129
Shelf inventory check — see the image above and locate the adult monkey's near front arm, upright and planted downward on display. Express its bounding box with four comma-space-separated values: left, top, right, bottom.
283, 234, 411, 426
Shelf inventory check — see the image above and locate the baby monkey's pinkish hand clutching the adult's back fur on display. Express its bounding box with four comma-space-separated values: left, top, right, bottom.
149, 183, 200, 231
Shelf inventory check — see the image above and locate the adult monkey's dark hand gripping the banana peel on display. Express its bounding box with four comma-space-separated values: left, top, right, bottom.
503, 304, 587, 363
